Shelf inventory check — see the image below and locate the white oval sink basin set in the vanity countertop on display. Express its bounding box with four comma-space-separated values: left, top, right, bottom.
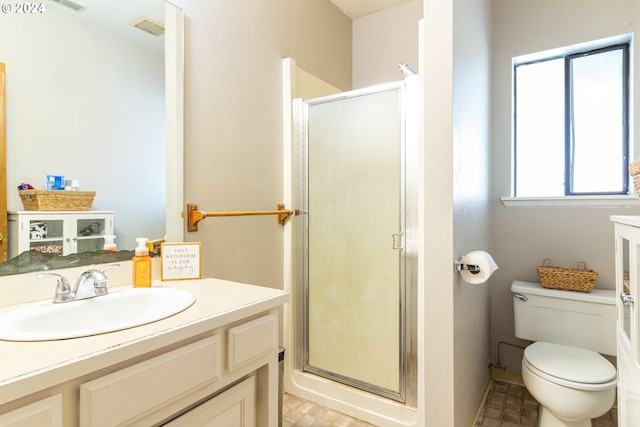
0, 288, 195, 341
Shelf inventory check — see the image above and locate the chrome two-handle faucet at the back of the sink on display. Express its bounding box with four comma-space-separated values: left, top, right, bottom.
36, 264, 120, 303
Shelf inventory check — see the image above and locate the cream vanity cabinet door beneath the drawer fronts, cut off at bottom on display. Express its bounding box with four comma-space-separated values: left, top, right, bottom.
165, 377, 256, 427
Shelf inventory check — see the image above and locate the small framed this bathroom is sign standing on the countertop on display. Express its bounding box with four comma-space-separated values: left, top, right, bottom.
160, 242, 202, 280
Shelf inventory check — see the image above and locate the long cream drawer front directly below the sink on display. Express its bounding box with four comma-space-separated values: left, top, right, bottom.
80, 335, 220, 427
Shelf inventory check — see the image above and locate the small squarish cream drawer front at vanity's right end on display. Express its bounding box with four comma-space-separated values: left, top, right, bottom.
227, 313, 278, 372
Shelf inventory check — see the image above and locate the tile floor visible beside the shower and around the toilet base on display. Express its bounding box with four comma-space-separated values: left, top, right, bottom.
282, 381, 618, 427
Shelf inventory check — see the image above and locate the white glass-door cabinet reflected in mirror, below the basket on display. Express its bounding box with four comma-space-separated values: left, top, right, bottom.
7, 211, 114, 258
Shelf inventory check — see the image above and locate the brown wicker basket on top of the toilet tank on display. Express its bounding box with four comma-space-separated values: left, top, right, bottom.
538, 258, 598, 292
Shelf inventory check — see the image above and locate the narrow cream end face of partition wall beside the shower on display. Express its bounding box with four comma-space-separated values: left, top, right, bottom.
418, 0, 455, 426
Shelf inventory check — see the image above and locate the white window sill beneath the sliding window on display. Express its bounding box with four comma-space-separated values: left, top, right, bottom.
501, 195, 640, 208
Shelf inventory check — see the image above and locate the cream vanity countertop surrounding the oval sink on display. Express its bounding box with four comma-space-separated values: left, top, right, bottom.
0, 279, 289, 404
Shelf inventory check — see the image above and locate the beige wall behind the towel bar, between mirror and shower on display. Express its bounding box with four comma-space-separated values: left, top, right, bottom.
169, 0, 351, 288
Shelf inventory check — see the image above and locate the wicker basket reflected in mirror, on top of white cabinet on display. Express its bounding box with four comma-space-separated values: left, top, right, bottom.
18, 190, 96, 211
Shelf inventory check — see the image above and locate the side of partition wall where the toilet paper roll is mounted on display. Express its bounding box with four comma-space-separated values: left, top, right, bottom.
452, 0, 492, 426
